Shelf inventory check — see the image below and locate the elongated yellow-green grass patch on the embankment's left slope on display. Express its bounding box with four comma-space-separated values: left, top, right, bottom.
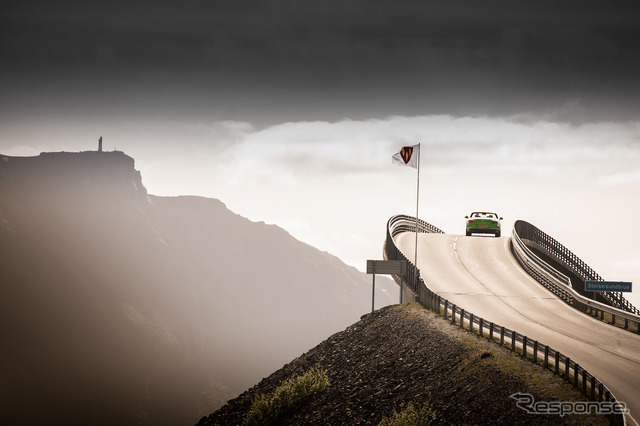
243, 367, 329, 425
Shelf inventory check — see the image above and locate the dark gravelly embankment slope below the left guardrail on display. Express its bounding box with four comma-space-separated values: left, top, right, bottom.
198, 304, 608, 426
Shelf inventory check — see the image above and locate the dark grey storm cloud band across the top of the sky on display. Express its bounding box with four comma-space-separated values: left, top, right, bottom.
0, 0, 640, 122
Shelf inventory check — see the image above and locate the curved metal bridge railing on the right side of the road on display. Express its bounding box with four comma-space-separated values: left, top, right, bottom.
511, 220, 640, 333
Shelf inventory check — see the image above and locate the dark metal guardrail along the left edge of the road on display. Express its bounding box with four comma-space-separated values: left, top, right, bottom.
384, 215, 627, 425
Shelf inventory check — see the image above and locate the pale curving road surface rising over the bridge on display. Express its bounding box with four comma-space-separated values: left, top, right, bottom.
396, 233, 640, 425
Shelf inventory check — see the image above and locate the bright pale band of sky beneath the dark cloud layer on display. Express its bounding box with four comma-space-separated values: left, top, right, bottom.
3, 114, 640, 310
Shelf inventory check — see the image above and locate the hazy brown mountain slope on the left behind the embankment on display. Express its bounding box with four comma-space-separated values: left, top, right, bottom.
0, 152, 397, 425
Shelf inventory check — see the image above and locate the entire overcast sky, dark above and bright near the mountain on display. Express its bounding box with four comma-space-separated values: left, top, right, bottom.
0, 0, 640, 305
